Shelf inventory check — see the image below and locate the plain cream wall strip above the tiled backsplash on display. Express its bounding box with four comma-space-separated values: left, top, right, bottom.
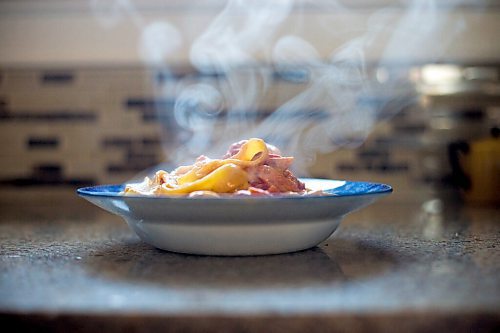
0, 0, 500, 66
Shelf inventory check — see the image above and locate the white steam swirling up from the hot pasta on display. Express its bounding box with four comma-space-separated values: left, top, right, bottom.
93, 0, 472, 175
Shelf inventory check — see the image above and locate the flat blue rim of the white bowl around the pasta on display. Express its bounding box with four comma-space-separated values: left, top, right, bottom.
76, 178, 393, 200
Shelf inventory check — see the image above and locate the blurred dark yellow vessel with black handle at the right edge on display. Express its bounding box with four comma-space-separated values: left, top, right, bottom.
449, 127, 500, 204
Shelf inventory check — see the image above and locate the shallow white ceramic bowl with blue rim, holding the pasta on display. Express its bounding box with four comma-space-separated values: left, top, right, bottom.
77, 178, 392, 256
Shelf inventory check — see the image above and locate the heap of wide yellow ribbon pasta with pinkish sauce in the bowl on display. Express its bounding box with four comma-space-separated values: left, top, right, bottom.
123, 138, 321, 197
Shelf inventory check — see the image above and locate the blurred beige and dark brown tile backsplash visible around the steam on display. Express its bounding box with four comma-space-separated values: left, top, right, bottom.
0, 63, 496, 204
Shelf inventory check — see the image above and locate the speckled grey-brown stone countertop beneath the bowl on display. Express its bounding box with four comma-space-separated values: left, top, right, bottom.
0, 190, 500, 332
